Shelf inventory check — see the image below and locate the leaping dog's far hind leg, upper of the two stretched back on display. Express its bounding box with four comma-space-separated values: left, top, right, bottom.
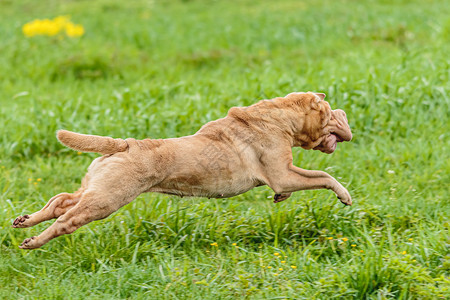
12, 176, 87, 228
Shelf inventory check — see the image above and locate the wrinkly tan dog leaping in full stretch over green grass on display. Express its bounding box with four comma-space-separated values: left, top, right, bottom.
13, 92, 352, 249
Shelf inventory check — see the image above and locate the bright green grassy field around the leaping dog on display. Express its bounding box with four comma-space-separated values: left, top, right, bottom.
0, 0, 450, 299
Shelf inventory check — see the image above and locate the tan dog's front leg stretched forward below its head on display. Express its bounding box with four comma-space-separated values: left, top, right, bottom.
268, 165, 352, 205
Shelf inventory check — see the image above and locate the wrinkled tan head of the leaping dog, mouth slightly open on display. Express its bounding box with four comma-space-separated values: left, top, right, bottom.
285, 92, 352, 154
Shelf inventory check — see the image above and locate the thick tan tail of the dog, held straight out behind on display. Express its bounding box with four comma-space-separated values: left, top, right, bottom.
56, 130, 128, 154
